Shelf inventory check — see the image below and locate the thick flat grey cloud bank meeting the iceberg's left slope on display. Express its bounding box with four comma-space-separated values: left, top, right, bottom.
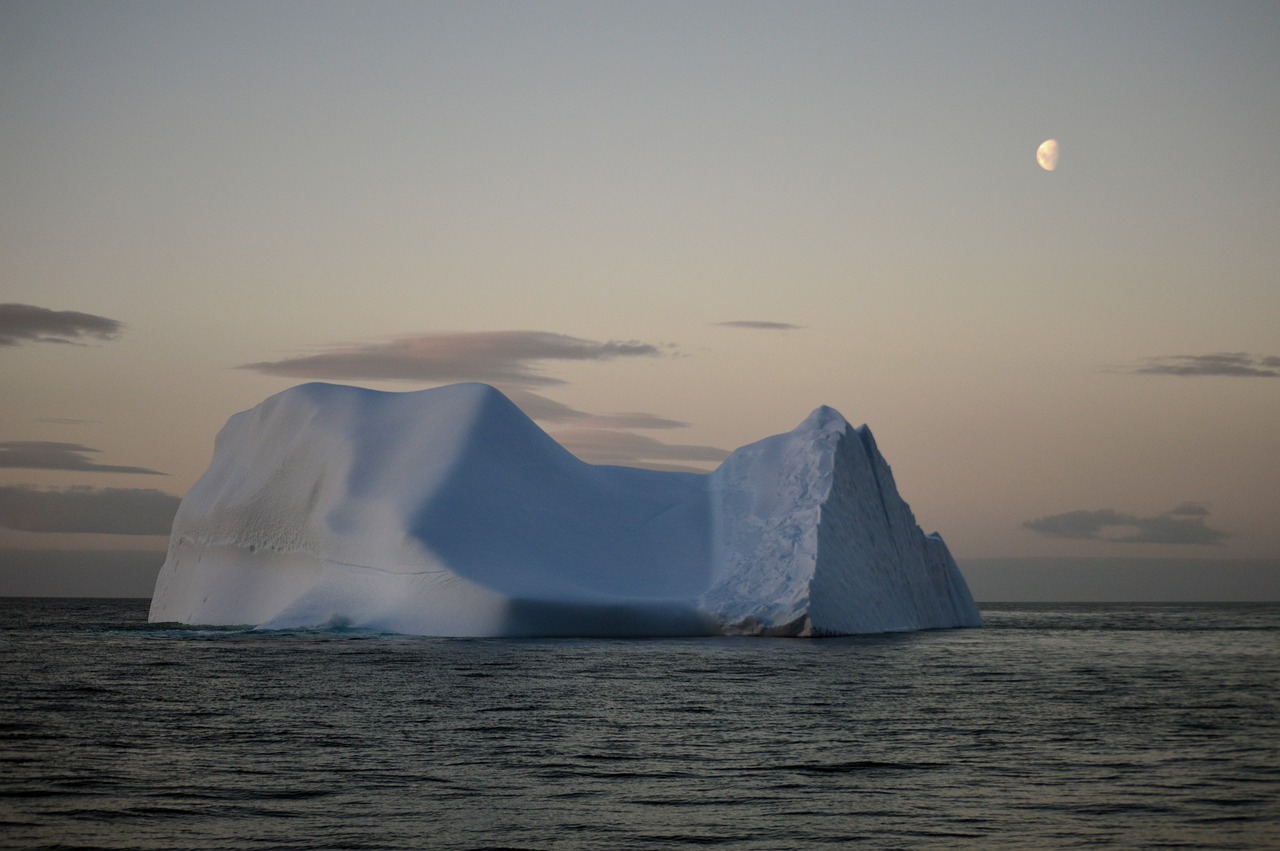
0, 485, 179, 535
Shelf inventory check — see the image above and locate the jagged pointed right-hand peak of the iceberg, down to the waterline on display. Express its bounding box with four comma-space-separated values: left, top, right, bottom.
699, 407, 982, 635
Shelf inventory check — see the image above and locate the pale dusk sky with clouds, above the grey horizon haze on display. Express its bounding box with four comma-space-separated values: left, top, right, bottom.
0, 0, 1280, 599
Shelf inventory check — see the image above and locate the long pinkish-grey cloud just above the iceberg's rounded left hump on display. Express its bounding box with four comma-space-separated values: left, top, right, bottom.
239, 331, 662, 385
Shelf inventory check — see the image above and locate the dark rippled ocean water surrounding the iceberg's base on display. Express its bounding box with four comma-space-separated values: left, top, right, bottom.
0, 599, 1280, 848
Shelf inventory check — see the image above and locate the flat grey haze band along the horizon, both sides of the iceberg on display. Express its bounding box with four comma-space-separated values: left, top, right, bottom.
0, 549, 1280, 603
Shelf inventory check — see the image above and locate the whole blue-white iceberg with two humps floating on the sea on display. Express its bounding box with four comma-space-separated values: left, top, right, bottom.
150, 384, 980, 636
